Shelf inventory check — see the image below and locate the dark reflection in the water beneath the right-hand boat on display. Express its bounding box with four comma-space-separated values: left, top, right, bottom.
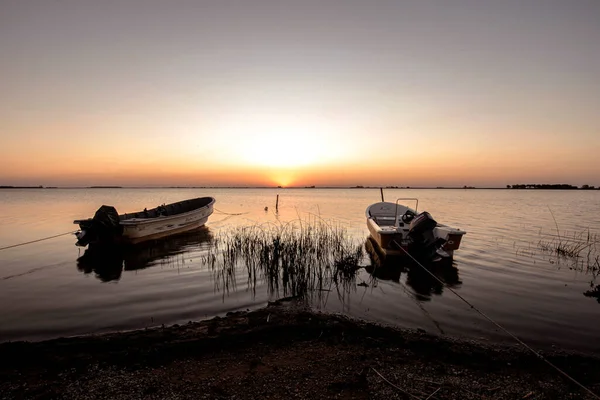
365, 238, 462, 301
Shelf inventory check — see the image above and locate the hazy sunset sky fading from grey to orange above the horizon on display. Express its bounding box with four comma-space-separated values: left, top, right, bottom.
0, 0, 600, 187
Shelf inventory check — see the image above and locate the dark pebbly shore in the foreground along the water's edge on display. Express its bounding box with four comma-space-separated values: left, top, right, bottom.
0, 302, 600, 400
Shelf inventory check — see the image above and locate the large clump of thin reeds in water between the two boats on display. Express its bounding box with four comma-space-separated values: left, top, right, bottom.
205, 217, 364, 298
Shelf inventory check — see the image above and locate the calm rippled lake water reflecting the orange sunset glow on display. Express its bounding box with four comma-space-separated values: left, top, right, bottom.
0, 189, 600, 351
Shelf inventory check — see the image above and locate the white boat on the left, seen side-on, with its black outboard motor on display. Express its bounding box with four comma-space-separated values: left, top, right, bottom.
73, 197, 215, 246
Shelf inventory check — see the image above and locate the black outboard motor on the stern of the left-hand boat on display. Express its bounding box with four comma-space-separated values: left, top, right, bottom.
75, 206, 123, 246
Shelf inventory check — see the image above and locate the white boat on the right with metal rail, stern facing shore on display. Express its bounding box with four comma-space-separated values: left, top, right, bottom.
366, 198, 466, 259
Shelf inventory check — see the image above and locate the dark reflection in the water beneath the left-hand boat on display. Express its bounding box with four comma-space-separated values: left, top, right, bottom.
77, 227, 213, 282
